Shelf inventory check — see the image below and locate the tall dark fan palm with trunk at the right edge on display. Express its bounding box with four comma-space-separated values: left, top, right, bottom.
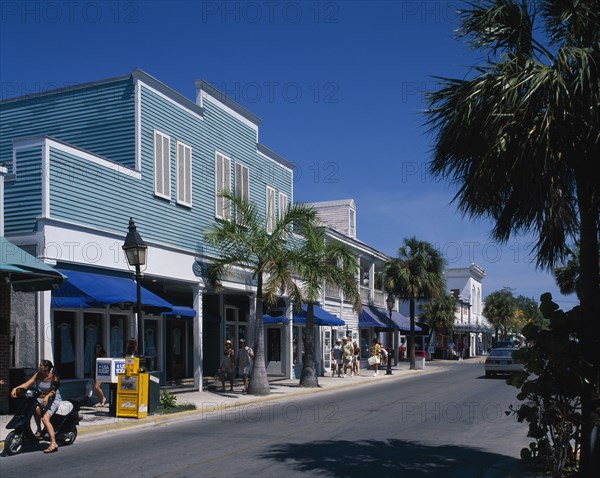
427, 0, 600, 474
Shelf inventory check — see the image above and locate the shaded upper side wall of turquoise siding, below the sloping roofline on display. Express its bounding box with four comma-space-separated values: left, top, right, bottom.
0, 80, 135, 168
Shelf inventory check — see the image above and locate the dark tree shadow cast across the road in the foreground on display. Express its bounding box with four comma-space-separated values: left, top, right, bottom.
262, 440, 518, 478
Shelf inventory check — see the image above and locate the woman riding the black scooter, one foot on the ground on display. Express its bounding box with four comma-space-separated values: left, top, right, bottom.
10, 360, 61, 453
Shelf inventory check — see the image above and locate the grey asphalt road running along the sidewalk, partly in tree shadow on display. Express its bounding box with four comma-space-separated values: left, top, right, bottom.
0, 362, 529, 478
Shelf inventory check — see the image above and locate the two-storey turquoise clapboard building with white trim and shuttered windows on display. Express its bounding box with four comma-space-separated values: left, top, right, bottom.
0, 70, 293, 387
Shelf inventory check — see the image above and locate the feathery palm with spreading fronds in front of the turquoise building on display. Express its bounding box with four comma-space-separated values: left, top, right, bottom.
205, 192, 317, 395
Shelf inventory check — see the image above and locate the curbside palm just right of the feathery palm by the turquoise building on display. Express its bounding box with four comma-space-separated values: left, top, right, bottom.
295, 227, 361, 387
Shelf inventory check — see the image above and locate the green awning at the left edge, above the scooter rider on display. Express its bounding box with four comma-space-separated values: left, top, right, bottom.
0, 236, 66, 292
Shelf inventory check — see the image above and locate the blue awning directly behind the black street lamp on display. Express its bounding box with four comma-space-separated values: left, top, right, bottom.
52, 270, 173, 311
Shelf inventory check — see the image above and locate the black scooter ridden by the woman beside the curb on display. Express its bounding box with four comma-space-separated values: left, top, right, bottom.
4, 388, 83, 455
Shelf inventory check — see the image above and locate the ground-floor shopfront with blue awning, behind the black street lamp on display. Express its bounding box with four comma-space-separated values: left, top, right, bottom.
51, 269, 195, 383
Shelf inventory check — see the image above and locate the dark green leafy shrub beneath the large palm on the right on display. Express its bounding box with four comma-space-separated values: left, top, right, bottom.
507, 294, 599, 477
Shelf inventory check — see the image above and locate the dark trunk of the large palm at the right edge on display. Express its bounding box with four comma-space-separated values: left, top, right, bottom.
576, 169, 600, 477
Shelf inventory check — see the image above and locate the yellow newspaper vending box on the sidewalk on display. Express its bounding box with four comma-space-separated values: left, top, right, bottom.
116, 357, 149, 418
